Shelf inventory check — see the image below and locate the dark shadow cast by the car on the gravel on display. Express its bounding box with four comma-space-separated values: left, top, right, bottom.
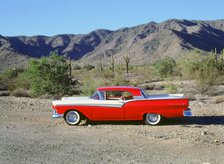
86, 116, 224, 126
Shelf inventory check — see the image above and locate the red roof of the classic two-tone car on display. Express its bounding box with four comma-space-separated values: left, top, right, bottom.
97, 86, 141, 96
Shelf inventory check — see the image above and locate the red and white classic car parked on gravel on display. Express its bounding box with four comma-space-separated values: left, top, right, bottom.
52, 86, 192, 125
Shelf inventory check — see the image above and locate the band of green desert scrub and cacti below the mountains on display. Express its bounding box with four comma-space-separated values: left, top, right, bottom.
0, 50, 224, 98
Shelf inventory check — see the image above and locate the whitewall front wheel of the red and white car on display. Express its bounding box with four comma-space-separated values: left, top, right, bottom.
64, 110, 81, 126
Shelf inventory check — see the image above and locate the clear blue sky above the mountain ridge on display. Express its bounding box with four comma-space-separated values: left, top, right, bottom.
0, 0, 224, 36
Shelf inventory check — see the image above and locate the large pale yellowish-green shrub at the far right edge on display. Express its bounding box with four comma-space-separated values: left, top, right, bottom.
178, 53, 224, 94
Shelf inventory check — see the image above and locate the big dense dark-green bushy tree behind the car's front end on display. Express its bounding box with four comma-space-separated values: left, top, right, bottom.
28, 52, 72, 96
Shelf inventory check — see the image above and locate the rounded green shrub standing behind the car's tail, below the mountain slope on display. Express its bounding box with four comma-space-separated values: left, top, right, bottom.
154, 57, 176, 77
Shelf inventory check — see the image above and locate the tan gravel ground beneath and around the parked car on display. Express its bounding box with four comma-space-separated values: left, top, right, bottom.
0, 97, 224, 163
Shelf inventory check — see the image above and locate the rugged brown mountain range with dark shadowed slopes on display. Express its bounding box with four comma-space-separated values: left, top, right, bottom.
0, 19, 224, 69
